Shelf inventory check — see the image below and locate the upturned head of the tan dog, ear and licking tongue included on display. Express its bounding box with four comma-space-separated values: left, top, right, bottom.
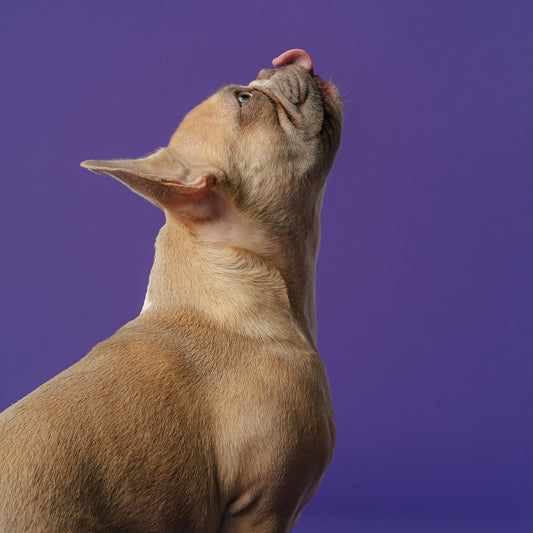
82, 50, 342, 252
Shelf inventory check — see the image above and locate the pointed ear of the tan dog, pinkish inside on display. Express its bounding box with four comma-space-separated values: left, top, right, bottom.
81, 148, 226, 223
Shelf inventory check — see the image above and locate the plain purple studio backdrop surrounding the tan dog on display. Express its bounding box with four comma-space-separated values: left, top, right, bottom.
0, 0, 533, 533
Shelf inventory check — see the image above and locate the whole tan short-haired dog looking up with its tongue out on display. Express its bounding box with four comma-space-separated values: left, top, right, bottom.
0, 49, 343, 533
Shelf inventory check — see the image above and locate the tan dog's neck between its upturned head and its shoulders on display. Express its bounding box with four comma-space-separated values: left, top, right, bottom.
141, 214, 316, 346
